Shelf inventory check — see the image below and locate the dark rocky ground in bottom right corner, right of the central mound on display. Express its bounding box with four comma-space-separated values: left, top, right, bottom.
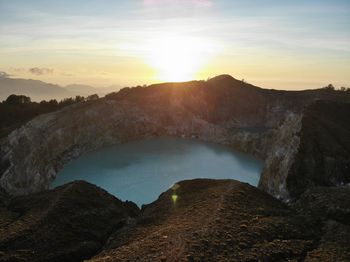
294, 186, 350, 262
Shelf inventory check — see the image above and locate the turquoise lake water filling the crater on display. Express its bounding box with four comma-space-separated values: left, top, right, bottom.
52, 137, 263, 206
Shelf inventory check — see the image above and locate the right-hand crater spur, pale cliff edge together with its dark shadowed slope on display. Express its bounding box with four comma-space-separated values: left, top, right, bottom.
259, 101, 350, 200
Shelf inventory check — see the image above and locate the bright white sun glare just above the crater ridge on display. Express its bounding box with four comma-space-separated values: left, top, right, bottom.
147, 36, 210, 82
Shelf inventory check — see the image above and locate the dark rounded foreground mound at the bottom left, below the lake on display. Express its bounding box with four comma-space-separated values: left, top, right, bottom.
0, 181, 139, 262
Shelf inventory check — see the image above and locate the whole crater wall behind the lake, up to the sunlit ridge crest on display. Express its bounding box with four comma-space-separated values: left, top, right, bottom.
0, 75, 350, 198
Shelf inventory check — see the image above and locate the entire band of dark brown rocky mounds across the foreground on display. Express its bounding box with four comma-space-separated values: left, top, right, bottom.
0, 179, 350, 262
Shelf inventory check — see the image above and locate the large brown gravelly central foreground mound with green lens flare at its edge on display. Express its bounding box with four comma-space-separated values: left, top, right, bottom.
92, 179, 315, 261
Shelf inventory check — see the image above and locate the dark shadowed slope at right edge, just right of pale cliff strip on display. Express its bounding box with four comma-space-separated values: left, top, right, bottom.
287, 101, 350, 197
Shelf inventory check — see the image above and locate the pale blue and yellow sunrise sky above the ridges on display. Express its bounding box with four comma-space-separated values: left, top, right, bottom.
0, 0, 350, 89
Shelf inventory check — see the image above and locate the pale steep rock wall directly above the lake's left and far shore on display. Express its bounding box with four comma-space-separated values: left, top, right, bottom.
0, 99, 266, 195
